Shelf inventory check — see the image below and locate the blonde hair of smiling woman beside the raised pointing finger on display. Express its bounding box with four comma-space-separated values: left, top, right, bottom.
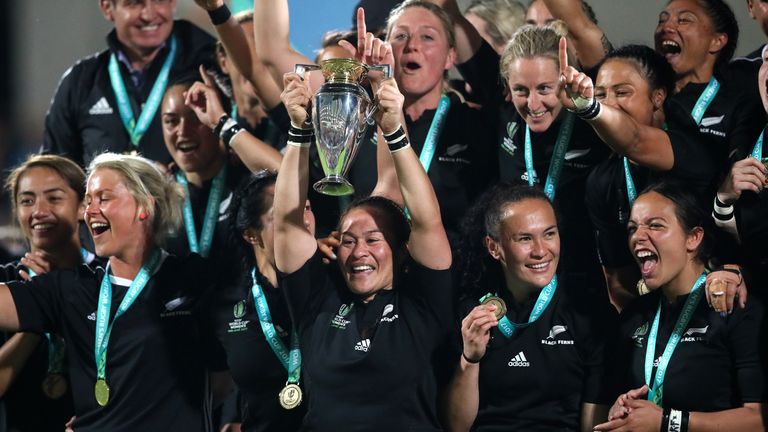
499, 20, 573, 82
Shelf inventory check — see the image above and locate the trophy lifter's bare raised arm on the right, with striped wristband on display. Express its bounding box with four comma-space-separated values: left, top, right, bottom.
376, 78, 451, 270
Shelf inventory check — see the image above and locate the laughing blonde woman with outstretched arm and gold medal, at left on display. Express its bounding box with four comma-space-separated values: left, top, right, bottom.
0, 153, 231, 431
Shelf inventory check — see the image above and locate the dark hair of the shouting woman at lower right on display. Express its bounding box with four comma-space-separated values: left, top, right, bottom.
635, 180, 714, 263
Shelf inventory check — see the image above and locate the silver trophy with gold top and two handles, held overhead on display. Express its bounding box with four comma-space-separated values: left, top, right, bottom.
295, 59, 392, 196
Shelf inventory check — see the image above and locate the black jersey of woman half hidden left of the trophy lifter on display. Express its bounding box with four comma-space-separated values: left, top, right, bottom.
214, 274, 307, 432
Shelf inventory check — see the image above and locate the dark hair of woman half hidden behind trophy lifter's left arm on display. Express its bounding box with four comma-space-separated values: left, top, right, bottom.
227, 170, 277, 268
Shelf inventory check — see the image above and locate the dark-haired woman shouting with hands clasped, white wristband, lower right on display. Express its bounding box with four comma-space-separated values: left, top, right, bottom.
595, 182, 766, 431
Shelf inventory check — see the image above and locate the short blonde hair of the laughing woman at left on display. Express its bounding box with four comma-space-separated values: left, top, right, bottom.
88, 153, 184, 246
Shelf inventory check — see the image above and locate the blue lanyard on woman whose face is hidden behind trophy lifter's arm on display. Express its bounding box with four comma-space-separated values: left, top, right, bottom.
251, 268, 301, 384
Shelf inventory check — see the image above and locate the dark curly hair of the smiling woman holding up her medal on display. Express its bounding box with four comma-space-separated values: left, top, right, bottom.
456, 182, 558, 296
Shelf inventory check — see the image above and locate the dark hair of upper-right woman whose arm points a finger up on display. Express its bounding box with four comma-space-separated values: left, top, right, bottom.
598, 45, 676, 96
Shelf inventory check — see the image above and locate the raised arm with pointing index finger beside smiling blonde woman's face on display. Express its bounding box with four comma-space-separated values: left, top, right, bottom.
559, 38, 675, 171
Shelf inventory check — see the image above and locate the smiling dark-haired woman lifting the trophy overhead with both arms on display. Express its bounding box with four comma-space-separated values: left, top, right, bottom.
274, 44, 453, 431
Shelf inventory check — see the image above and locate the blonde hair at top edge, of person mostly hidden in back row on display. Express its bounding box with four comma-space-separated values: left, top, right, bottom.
464, 0, 525, 49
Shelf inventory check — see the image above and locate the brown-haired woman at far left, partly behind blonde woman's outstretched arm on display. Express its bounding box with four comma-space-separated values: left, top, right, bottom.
0, 155, 98, 430
